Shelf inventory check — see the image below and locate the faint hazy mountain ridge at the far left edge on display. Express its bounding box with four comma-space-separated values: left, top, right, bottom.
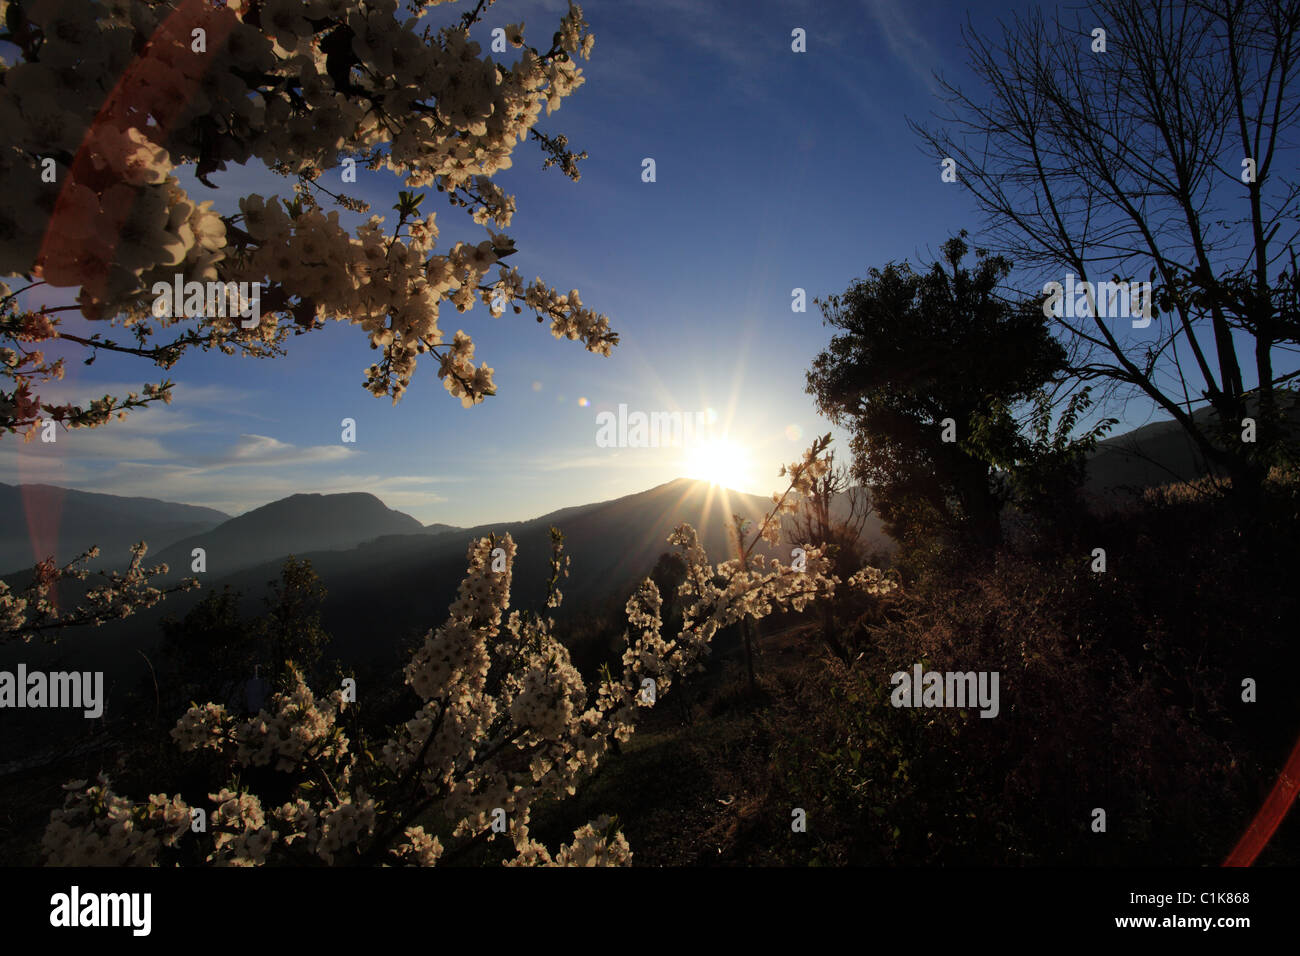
0, 483, 230, 575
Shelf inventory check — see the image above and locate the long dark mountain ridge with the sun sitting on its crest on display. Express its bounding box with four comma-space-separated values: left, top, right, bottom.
0, 479, 885, 762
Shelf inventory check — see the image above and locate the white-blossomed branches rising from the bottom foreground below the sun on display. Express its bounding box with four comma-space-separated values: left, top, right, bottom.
46, 442, 894, 865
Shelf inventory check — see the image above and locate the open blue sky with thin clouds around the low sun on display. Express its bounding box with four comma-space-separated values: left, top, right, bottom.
0, 0, 1274, 525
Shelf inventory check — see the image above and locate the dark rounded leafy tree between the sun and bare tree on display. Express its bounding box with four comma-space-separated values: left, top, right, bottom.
807, 232, 1066, 554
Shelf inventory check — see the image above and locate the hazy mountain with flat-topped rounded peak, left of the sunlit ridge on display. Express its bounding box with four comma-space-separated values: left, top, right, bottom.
150, 492, 425, 578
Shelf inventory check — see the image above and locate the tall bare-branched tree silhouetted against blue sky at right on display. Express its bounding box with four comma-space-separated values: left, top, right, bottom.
913, 0, 1300, 488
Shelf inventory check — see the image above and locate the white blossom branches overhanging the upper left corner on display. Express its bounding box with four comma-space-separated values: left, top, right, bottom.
0, 0, 618, 434
